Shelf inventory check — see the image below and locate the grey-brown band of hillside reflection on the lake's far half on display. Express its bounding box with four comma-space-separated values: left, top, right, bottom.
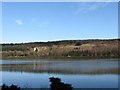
2, 60, 118, 74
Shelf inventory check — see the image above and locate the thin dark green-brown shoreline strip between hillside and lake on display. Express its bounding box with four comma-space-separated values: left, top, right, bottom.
1, 56, 119, 61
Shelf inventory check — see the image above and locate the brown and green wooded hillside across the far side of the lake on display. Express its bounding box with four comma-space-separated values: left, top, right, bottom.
1, 39, 120, 59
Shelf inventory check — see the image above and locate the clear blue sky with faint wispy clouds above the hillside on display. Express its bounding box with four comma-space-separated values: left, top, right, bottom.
2, 2, 118, 43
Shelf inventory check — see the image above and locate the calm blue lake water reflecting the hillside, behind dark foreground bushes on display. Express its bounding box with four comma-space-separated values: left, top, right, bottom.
0, 59, 118, 88
